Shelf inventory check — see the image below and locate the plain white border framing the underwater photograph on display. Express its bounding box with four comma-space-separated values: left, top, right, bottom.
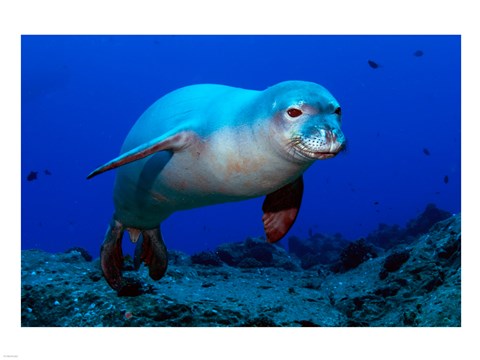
0, 0, 480, 359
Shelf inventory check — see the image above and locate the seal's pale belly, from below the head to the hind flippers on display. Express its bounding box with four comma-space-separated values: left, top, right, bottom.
114, 126, 306, 228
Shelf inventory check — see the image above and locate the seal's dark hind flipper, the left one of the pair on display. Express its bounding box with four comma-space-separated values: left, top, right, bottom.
100, 219, 124, 291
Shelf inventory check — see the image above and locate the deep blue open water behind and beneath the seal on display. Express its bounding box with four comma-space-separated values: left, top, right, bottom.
21, 35, 461, 257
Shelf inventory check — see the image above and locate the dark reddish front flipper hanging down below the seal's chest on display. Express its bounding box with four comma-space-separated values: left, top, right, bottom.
262, 176, 303, 243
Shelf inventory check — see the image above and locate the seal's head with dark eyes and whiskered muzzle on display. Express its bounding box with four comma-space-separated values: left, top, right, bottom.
262, 81, 345, 162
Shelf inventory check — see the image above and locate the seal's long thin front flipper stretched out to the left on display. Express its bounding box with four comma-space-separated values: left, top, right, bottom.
87, 130, 197, 179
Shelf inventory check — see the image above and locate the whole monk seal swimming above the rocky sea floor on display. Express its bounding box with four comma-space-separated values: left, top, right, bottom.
87, 81, 345, 291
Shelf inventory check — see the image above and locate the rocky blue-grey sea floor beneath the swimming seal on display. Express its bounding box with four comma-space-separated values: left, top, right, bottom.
21, 207, 461, 327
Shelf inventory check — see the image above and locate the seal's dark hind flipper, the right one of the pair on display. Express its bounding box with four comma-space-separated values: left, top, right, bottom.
141, 228, 168, 280
